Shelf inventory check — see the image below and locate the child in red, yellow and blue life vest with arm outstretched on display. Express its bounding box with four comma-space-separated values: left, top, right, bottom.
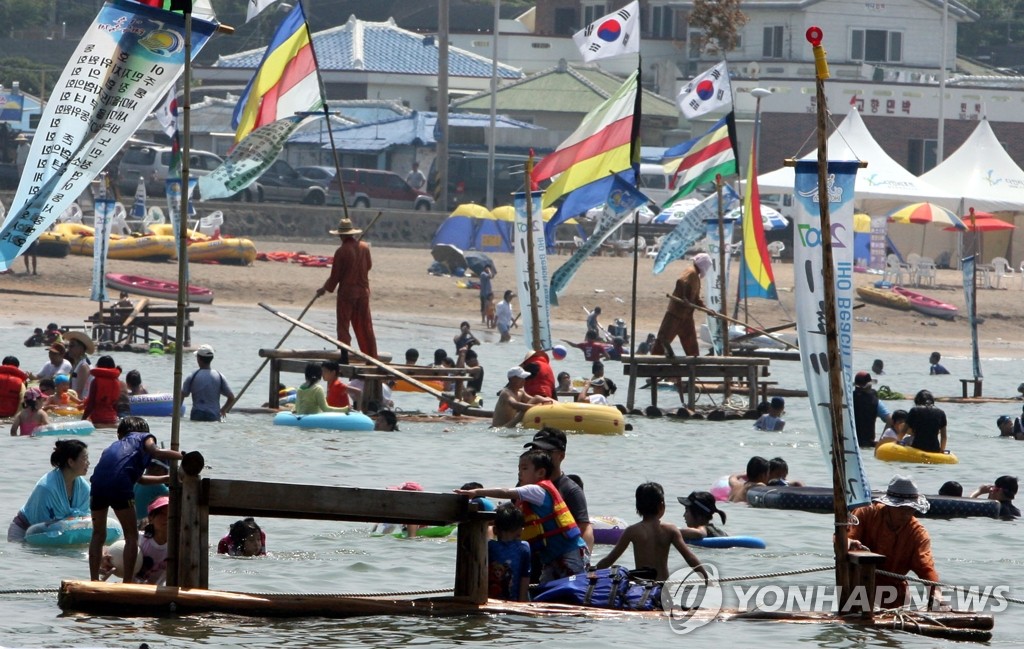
455, 449, 588, 583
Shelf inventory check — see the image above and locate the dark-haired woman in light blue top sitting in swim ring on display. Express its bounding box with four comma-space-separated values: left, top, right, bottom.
7, 439, 89, 540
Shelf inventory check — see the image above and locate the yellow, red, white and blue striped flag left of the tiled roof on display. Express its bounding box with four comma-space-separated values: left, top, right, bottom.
231, 2, 323, 143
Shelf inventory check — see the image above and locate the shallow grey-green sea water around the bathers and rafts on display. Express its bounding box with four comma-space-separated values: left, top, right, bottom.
0, 306, 1024, 647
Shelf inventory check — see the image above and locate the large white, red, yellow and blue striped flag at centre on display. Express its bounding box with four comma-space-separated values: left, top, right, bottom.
532, 72, 640, 241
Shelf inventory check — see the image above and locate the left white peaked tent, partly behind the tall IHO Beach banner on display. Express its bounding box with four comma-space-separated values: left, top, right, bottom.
758, 110, 959, 215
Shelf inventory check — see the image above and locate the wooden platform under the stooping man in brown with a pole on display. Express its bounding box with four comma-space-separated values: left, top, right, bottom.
623, 355, 771, 410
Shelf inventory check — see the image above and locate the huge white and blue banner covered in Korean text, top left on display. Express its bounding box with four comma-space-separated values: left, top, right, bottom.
0, 0, 216, 270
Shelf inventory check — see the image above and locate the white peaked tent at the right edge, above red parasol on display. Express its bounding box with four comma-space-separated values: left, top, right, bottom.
921, 120, 1024, 213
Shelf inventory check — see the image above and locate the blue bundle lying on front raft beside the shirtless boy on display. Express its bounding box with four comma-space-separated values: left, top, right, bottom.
530, 566, 662, 611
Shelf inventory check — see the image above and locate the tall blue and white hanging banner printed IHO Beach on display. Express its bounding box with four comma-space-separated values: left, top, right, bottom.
793, 161, 871, 508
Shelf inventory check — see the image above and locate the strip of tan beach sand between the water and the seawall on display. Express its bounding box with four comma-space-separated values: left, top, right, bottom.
0, 237, 1024, 356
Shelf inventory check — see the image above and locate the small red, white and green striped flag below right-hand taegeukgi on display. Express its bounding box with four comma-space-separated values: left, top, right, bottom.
663, 113, 738, 207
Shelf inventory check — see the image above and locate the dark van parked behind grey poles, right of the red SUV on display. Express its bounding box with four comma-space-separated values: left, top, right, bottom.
427, 150, 526, 210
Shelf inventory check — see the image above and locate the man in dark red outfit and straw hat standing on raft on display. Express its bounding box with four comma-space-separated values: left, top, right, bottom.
316, 219, 377, 358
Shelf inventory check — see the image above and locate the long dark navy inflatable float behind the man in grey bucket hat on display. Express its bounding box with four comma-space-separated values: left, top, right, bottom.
746, 486, 999, 518
